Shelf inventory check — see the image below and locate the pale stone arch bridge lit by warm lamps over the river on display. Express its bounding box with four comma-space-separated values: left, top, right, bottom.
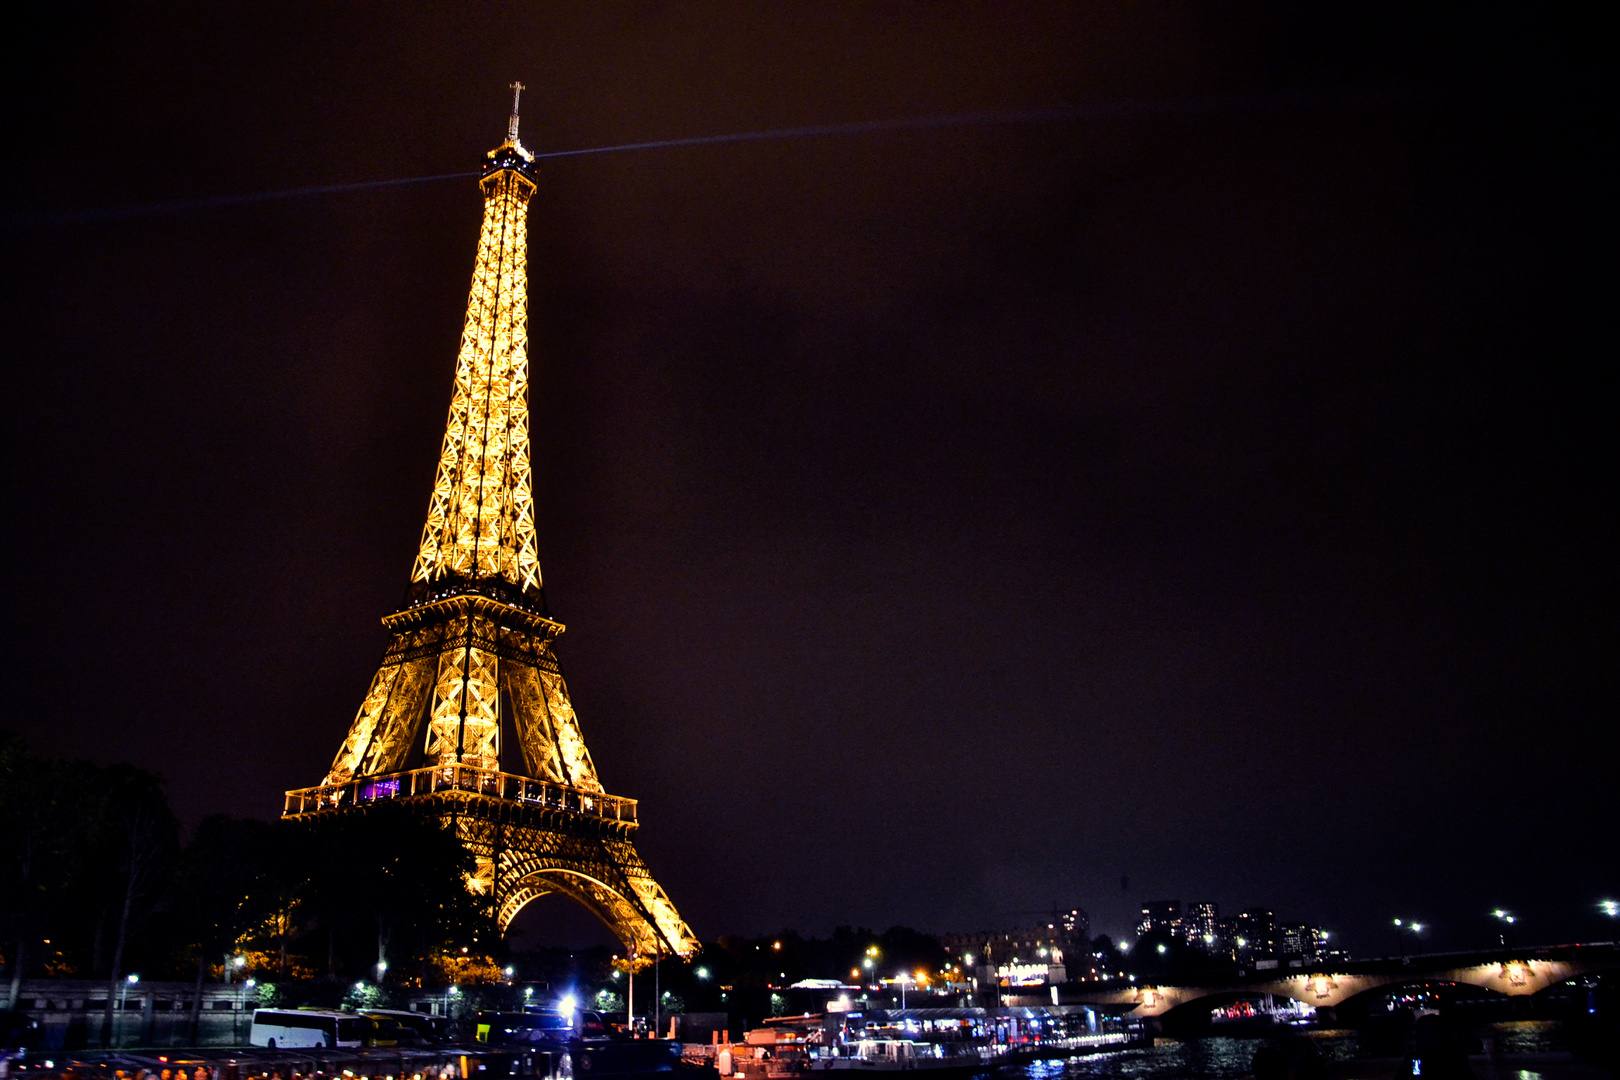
1061, 942, 1620, 1017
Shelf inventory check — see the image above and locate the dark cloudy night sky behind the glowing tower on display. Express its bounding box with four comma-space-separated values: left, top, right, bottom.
0, 3, 1620, 954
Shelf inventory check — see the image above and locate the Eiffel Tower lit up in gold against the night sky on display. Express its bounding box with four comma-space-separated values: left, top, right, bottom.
284, 83, 698, 963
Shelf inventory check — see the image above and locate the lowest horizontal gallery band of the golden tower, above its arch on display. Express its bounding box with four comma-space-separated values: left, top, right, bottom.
284, 764, 635, 821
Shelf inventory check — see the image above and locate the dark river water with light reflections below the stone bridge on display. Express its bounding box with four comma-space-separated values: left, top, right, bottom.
995, 1020, 1587, 1080
